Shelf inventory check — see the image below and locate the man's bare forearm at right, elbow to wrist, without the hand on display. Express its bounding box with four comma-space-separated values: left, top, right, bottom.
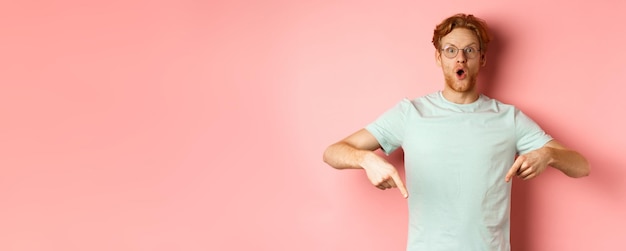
546, 147, 590, 178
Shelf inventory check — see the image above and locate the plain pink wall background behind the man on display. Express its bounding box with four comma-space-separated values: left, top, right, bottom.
0, 0, 626, 251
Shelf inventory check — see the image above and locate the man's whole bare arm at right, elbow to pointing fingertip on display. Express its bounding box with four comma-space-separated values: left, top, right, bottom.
505, 140, 590, 182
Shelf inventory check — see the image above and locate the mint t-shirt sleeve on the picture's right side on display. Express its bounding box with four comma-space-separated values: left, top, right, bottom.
515, 109, 552, 155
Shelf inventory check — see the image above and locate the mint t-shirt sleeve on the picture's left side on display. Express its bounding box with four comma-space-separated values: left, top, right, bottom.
365, 98, 413, 155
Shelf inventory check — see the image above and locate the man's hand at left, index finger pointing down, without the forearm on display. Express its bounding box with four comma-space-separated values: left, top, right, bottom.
361, 152, 409, 199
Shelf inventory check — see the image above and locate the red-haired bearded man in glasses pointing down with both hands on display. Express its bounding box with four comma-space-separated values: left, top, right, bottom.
324, 14, 589, 251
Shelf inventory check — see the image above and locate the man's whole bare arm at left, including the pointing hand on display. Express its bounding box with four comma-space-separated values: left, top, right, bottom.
324, 129, 408, 198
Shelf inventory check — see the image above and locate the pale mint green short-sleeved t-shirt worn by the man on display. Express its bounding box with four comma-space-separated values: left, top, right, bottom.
366, 91, 552, 251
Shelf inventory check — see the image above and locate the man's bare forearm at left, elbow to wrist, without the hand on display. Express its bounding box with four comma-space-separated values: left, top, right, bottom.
324, 142, 373, 169
